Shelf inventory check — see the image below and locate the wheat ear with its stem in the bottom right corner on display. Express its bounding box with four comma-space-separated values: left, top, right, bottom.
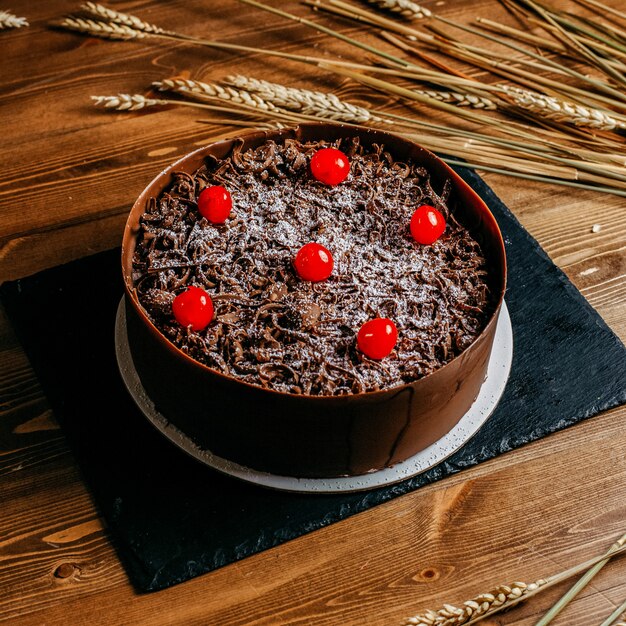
404, 535, 626, 626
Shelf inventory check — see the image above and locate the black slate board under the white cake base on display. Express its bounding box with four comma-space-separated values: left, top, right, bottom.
0, 168, 626, 591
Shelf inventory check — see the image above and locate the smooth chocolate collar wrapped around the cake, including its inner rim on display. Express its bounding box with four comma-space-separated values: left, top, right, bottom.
122, 124, 506, 477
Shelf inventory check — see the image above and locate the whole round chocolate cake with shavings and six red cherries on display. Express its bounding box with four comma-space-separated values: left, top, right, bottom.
122, 124, 506, 477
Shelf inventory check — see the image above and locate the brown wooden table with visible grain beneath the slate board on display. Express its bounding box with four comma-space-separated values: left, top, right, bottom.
0, 0, 626, 626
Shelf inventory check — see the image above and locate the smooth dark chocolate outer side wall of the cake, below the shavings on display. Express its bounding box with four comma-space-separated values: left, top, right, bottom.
126, 300, 495, 477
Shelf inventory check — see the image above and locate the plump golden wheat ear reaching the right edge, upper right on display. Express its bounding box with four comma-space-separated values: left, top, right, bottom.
502, 85, 626, 130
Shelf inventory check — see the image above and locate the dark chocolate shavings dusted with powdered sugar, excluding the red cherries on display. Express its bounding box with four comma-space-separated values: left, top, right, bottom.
133, 139, 494, 395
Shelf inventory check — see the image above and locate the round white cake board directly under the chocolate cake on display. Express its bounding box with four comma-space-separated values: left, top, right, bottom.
115, 298, 513, 493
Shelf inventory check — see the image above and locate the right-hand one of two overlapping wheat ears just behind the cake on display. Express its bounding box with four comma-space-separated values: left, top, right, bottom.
225, 75, 380, 124
